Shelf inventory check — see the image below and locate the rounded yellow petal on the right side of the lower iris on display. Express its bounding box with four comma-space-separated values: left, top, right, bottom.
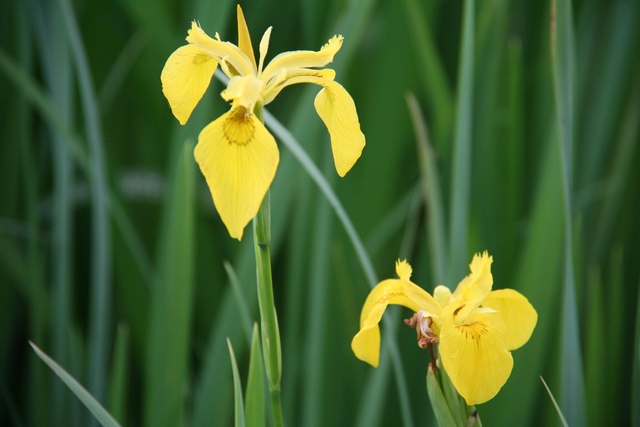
482, 289, 538, 350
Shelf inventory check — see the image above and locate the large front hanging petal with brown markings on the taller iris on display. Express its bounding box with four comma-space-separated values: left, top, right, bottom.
194, 107, 279, 240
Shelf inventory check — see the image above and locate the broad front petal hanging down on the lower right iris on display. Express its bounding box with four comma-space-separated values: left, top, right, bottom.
440, 313, 513, 405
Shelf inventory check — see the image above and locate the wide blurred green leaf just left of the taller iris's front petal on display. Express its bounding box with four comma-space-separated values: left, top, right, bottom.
144, 142, 195, 427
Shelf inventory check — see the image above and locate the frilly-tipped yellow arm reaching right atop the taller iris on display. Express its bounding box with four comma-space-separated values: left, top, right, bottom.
262, 36, 342, 80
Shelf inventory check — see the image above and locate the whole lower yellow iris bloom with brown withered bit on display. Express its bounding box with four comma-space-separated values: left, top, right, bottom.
351, 251, 538, 406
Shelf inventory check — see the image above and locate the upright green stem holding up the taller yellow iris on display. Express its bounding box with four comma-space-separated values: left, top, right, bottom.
253, 106, 284, 427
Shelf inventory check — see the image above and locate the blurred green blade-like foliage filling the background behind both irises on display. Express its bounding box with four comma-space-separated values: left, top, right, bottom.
0, 0, 640, 426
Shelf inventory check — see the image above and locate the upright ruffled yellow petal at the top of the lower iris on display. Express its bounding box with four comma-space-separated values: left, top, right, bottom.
451, 251, 493, 322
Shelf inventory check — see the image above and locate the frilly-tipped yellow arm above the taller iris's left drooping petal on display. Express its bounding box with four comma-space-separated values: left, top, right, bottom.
187, 21, 256, 78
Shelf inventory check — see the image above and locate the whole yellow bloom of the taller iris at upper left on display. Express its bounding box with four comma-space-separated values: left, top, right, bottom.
161, 6, 365, 240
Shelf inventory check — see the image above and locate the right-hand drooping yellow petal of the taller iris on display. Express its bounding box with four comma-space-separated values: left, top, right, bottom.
313, 80, 365, 176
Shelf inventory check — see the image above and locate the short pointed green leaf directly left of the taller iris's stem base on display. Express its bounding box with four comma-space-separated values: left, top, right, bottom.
245, 323, 266, 427
